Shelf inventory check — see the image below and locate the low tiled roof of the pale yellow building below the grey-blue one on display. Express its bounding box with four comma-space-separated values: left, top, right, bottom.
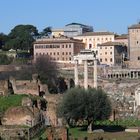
79, 32, 114, 36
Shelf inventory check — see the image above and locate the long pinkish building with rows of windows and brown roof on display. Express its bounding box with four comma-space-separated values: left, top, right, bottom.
34, 36, 84, 63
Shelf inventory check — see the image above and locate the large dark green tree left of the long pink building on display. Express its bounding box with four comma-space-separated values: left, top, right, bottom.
5, 25, 38, 50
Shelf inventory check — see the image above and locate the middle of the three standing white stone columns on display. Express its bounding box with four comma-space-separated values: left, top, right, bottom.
84, 60, 88, 89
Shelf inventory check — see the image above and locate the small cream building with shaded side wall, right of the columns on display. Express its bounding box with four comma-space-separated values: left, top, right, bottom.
98, 42, 127, 66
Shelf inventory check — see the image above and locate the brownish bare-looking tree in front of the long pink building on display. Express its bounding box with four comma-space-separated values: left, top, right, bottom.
35, 56, 59, 93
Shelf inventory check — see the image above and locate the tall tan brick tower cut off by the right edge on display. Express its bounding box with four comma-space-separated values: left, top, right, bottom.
128, 23, 140, 68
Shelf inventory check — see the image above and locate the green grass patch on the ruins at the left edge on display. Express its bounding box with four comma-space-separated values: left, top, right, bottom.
0, 95, 27, 112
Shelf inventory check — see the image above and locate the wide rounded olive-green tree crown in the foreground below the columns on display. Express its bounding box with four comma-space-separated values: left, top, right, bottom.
58, 88, 111, 130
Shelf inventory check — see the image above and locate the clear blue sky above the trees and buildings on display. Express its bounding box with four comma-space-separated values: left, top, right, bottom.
0, 0, 140, 34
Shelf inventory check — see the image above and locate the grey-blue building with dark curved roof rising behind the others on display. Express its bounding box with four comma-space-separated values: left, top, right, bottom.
64, 23, 93, 37
